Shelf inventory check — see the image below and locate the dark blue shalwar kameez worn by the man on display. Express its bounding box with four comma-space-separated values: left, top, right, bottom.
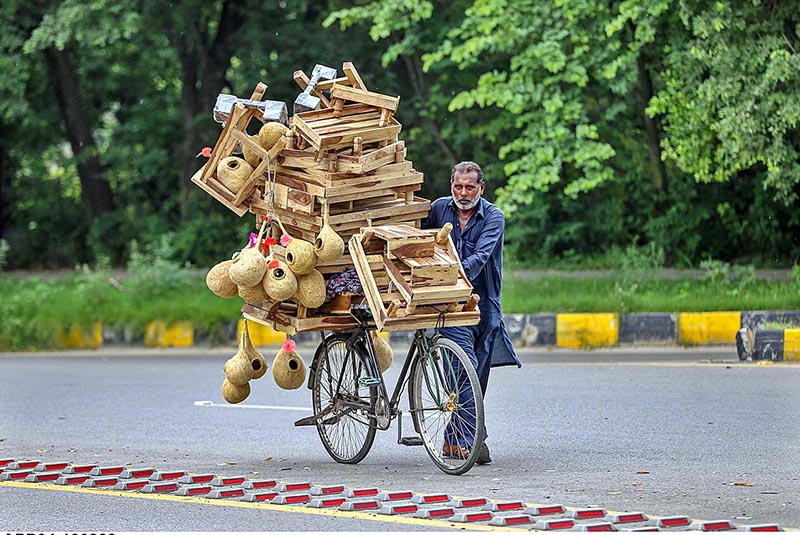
422, 197, 522, 448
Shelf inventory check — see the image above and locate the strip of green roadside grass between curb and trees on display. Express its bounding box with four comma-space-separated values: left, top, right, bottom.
0, 238, 800, 350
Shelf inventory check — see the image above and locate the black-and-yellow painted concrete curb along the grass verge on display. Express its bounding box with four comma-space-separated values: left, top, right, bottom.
43, 310, 800, 354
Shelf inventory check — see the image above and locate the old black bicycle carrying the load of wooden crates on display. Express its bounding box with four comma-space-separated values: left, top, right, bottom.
295, 304, 484, 475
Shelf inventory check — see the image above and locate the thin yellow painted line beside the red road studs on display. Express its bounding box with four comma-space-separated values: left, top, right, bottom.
0, 481, 531, 532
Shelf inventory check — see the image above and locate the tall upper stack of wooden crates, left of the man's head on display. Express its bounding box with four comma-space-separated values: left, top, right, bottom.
254, 63, 430, 245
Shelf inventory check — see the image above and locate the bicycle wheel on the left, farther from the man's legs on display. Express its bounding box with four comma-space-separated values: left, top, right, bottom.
311, 334, 377, 464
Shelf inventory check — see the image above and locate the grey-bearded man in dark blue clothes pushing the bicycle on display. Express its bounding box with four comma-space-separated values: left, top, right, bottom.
423, 162, 522, 464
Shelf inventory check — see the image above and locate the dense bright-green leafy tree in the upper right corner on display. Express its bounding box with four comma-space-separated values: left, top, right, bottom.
649, 0, 800, 204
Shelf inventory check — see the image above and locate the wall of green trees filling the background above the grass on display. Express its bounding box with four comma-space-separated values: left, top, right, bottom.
0, 0, 800, 268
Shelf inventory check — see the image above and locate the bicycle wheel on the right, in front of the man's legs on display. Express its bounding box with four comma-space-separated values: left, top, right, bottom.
408, 338, 484, 475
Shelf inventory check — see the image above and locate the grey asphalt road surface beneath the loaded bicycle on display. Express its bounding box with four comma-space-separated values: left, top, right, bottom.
0, 348, 800, 531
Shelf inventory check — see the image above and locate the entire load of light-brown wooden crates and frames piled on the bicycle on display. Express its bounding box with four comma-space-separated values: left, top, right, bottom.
193, 62, 478, 334
